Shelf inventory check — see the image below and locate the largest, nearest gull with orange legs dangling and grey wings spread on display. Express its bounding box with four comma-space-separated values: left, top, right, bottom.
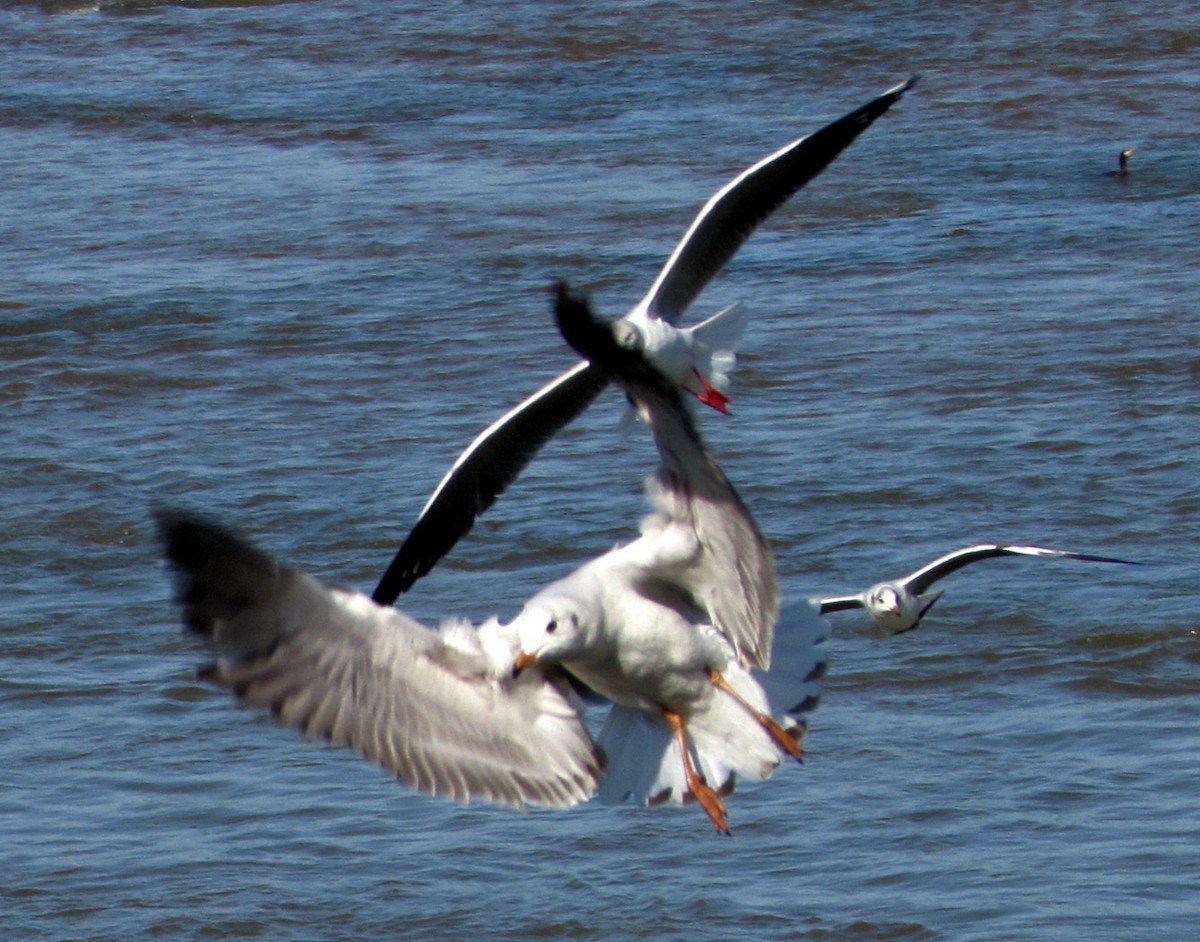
157, 289, 827, 832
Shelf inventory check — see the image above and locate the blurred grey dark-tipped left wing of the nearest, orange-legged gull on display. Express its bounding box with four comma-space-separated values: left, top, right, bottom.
158, 514, 602, 806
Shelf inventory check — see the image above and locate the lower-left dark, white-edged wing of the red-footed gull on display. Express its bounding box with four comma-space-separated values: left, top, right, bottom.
371, 362, 608, 605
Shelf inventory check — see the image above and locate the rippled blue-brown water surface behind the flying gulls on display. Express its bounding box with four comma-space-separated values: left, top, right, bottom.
0, 0, 1200, 941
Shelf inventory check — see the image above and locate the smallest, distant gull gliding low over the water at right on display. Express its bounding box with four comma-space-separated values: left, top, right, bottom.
817, 542, 1138, 635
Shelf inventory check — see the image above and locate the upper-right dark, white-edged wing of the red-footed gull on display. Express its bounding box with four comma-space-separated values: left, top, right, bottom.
642, 78, 917, 324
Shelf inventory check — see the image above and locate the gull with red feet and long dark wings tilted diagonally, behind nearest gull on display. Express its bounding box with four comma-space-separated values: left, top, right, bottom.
372, 78, 917, 605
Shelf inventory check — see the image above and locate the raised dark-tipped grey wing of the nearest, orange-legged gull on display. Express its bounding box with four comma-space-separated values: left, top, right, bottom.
556, 286, 779, 670
